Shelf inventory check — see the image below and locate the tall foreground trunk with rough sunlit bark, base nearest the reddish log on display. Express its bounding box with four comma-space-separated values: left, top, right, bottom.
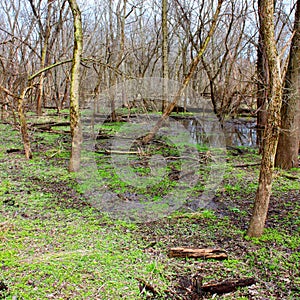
247, 0, 282, 237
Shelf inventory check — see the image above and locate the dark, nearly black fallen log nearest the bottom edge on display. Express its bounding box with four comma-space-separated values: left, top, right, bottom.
198, 278, 256, 295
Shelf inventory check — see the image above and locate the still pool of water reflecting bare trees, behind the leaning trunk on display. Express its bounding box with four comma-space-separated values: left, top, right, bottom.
181, 118, 257, 147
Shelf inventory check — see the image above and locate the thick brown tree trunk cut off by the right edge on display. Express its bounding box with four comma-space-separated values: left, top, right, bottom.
275, 0, 300, 170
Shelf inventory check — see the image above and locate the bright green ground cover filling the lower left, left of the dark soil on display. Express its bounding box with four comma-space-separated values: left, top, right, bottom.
0, 123, 168, 299
